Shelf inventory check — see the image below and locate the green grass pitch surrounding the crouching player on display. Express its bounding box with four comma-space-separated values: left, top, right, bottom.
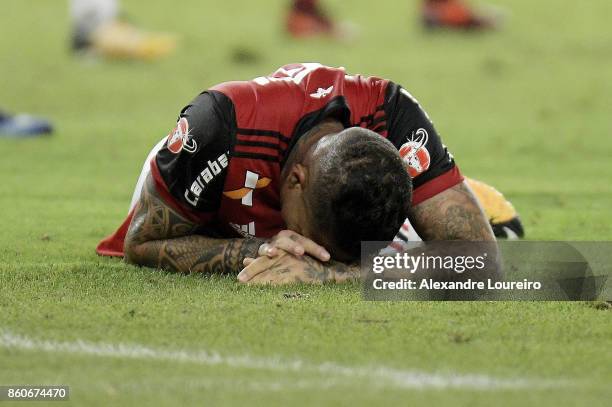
0, 0, 612, 406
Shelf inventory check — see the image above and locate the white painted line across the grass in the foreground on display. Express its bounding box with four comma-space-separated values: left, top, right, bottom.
0, 329, 566, 390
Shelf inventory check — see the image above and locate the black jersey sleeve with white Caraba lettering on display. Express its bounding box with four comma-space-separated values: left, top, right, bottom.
151, 91, 235, 222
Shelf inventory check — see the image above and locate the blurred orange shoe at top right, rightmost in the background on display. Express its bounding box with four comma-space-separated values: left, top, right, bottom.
423, 0, 498, 29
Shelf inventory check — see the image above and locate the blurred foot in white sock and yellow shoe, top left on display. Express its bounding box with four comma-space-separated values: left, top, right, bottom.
70, 0, 176, 60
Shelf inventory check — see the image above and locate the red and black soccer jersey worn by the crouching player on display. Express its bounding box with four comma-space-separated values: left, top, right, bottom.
151, 63, 462, 237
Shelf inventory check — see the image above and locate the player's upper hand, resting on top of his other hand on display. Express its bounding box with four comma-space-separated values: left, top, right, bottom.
252, 230, 331, 266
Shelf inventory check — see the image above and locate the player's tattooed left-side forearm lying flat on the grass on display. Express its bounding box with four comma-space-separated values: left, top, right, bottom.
125, 235, 264, 274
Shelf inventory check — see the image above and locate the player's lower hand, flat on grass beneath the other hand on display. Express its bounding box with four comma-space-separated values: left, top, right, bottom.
238, 250, 360, 285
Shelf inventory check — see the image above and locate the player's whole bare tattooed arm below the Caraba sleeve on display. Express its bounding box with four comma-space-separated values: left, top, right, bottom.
125, 175, 264, 274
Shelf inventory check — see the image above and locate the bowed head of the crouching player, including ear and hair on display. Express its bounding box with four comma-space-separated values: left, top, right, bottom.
281, 123, 412, 261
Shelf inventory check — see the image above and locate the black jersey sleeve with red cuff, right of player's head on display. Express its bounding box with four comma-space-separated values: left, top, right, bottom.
385, 82, 463, 205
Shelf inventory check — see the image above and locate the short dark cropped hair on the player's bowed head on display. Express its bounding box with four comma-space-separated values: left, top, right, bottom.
307, 127, 412, 260
